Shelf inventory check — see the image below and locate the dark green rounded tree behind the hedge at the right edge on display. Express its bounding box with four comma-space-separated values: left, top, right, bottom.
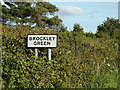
97, 17, 120, 37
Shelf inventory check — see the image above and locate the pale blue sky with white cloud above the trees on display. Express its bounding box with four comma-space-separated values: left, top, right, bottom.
0, 0, 119, 33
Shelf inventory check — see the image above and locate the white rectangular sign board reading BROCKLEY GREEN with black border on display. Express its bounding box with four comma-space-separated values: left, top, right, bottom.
27, 34, 57, 48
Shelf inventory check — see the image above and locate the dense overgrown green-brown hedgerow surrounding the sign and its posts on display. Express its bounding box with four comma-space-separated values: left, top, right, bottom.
2, 26, 118, 89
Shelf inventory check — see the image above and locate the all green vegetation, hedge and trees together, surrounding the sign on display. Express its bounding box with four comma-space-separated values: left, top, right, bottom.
2, 2, 120, 89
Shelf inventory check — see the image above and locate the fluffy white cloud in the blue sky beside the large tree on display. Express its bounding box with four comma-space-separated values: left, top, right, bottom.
57, 6, 83, 16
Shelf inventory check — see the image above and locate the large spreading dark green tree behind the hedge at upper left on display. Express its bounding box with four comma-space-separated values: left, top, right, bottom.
2, 2, 62, 28
